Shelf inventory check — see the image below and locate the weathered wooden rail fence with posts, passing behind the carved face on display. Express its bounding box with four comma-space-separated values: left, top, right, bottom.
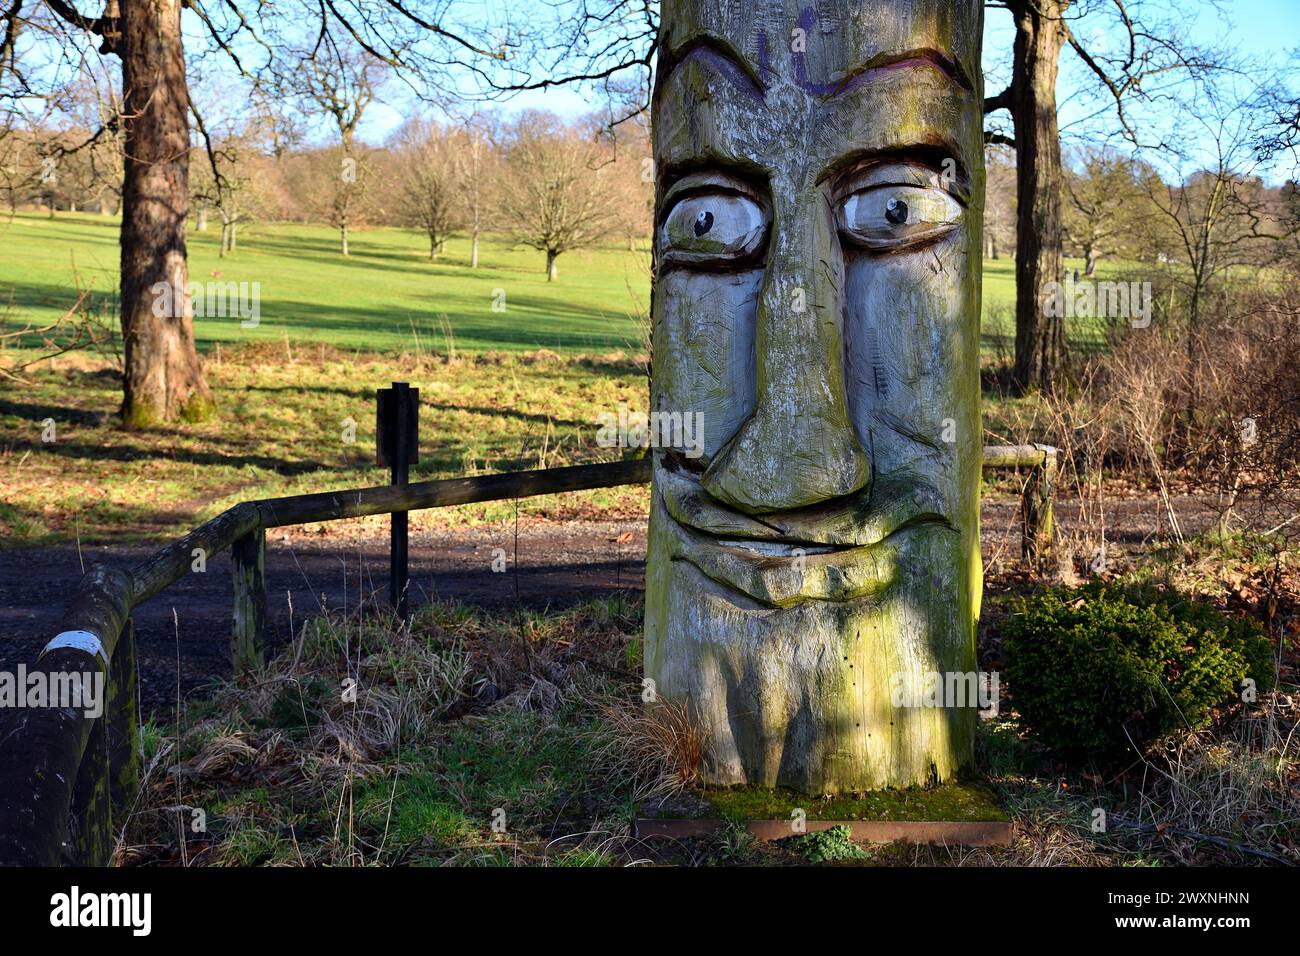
0, 445, 1057, 866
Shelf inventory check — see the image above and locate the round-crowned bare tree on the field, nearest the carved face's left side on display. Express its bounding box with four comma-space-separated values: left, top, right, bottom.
499, 112, 618, 282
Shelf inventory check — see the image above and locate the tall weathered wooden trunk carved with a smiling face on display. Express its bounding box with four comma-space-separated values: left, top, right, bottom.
646, 0, 983, 792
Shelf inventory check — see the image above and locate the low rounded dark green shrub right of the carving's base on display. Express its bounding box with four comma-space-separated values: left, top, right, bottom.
1004, 584, 1273, 760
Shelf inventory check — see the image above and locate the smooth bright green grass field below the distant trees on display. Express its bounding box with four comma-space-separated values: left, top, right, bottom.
0, 213, 1055, 354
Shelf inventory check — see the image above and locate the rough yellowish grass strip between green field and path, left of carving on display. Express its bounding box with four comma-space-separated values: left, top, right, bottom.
0, 343, 649, 546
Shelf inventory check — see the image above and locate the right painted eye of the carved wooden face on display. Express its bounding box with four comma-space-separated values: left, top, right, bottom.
840, 185, 963, 251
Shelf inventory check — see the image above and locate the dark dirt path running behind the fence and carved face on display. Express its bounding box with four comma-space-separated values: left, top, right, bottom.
0, 498, 1237, 711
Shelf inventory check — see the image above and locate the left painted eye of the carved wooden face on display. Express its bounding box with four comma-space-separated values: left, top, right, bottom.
659, 191, 767, 265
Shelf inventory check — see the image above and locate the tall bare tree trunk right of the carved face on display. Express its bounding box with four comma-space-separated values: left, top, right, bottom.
1011, 0, 1070, 390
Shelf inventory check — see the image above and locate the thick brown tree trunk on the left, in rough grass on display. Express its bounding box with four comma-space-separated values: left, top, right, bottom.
118, 0, 212, 428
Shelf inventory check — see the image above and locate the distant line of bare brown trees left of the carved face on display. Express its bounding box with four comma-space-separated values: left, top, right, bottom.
0, 84, 654, 280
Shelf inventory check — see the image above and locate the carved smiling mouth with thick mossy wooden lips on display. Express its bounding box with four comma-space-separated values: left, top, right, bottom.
654, 464, 957, 607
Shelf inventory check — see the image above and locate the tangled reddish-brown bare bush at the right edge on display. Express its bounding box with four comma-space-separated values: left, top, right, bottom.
1053, 265, 1300, 540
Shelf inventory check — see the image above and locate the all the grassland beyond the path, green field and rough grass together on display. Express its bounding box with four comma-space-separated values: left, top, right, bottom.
0, 215, 1076, 546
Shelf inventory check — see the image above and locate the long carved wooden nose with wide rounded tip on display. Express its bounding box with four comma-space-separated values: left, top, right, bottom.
703, 186, 871, 514
